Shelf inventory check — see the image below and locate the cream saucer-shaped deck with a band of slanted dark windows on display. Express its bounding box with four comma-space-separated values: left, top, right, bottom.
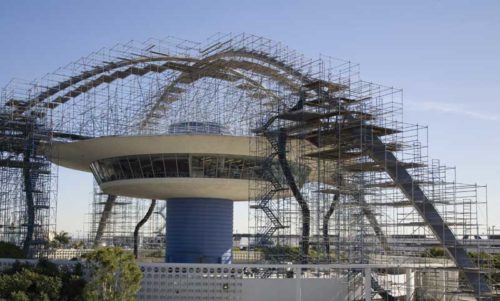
51, 134, 270, 201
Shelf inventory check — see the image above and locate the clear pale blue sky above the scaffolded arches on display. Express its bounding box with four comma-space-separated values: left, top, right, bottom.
0, 0, 500, 232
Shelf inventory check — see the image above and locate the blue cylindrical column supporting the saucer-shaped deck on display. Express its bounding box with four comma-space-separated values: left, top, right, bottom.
166, 198, 233, 263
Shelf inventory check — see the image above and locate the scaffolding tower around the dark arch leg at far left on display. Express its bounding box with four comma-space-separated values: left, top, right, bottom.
0, 82, 57, 257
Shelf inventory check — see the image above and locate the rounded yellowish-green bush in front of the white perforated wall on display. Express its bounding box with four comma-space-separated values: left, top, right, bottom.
84, 247, 142, 301
